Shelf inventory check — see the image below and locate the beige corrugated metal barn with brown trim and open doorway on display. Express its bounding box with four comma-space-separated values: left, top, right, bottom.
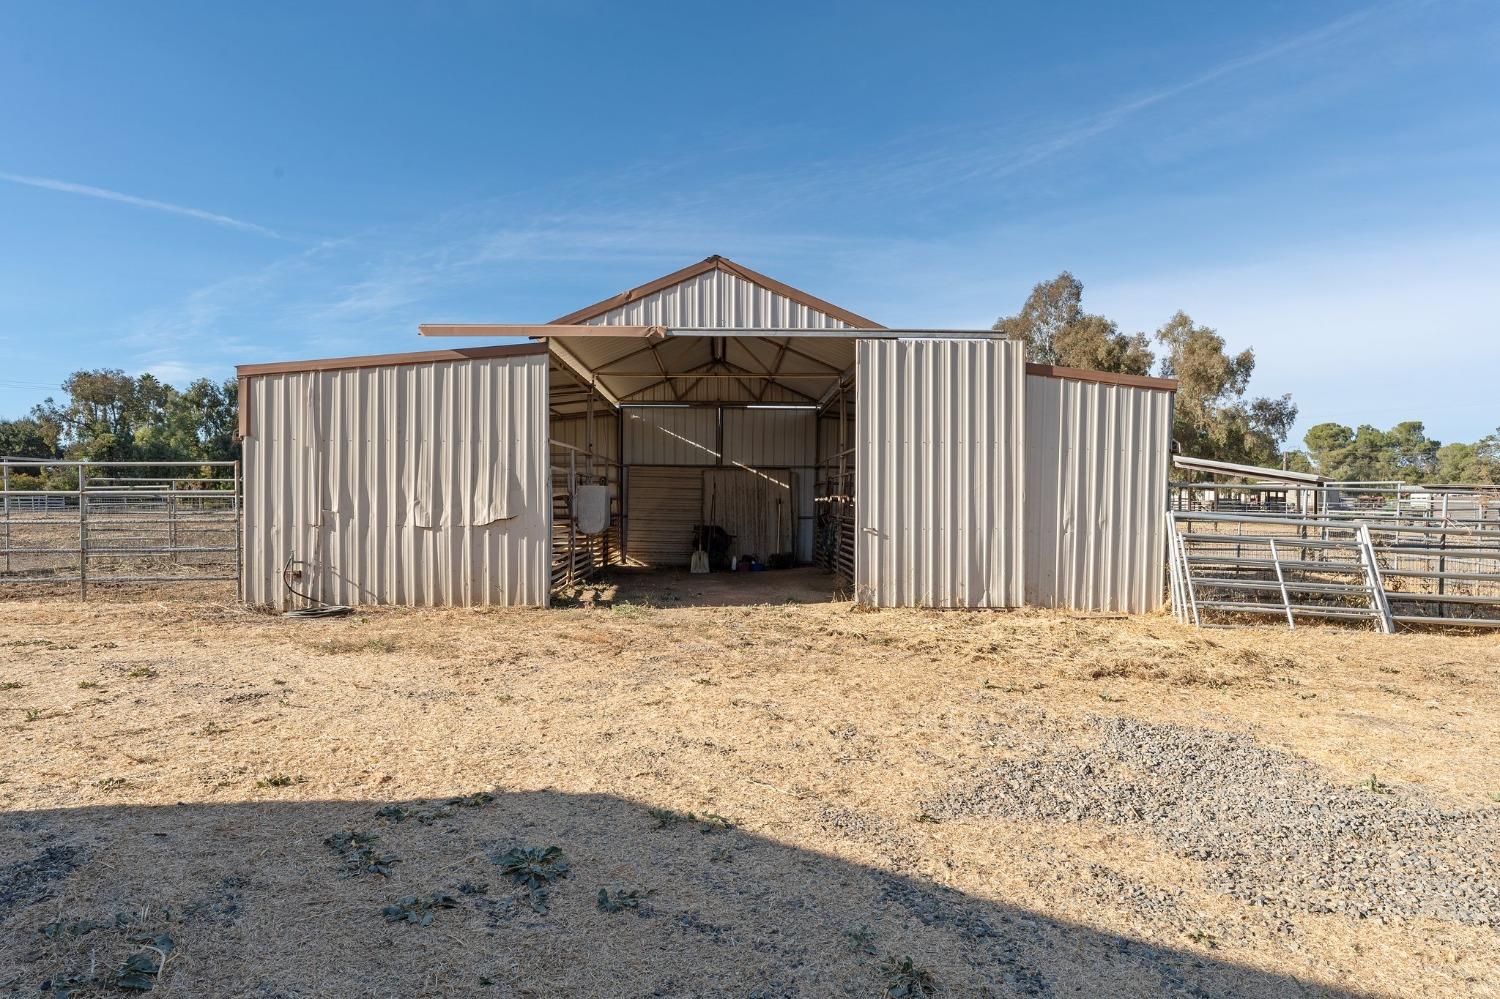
239, 257, 1175, 612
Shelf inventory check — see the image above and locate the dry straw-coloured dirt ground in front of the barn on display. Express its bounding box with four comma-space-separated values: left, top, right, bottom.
0, 573, 1500, 999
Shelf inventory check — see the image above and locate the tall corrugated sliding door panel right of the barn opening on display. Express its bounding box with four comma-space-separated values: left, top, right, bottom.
855, 339, 1026, 608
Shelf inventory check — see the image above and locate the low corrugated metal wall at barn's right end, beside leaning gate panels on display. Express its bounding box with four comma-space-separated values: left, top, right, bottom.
1026, 375, 1172, 614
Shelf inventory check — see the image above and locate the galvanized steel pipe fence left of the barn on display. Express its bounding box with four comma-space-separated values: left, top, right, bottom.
0, 459, 243, 599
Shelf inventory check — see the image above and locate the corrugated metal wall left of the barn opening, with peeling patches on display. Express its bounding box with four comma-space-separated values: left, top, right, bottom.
245, 354, 551, 608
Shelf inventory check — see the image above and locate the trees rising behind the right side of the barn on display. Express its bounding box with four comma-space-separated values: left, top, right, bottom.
995, 272, 1500, 485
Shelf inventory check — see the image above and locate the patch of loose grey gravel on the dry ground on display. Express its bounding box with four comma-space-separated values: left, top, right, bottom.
926, 717, 1500, 927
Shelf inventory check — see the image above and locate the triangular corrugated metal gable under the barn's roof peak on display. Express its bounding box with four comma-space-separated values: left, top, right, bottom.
588, 270, 848, 330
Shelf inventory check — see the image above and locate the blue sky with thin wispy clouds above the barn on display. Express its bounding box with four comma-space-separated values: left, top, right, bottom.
0, 0, 1500, 440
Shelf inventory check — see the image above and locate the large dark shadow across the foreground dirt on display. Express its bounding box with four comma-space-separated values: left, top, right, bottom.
0, 786, 1353, 999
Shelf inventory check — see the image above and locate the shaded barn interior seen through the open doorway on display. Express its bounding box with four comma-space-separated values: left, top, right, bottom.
545, 327, 855, 602
